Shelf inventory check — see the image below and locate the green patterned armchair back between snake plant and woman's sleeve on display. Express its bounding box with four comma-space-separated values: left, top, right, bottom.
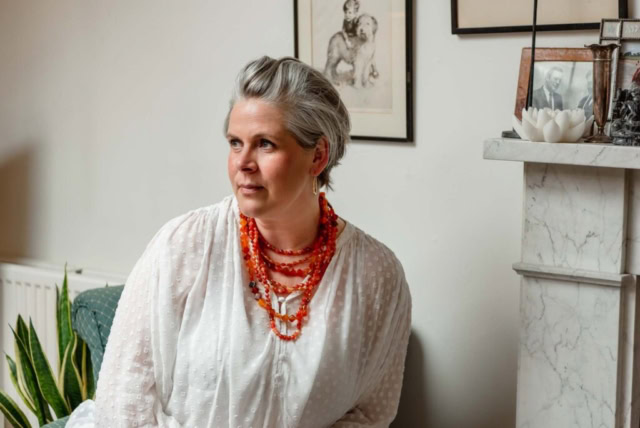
71, 285, 124, 384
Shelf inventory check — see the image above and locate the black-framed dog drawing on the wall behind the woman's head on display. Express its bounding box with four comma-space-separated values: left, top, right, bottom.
294, 0, 413, 142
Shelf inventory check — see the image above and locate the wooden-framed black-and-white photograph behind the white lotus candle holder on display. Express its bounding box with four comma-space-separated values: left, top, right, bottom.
515, 48, 593, 120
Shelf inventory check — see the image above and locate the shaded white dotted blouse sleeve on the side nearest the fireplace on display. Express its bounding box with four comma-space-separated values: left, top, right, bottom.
332, 252, 411, 428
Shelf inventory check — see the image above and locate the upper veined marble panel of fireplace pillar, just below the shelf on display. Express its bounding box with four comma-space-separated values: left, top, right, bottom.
522, 163, 626, 273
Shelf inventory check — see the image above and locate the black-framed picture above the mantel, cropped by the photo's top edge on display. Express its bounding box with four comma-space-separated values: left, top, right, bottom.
451, 0, 629, 34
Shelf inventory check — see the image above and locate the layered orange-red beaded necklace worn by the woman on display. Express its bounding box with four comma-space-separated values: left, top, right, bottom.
240, 193, 338, 340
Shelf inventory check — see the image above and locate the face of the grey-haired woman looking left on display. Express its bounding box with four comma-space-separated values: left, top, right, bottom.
227, 98, 314, 220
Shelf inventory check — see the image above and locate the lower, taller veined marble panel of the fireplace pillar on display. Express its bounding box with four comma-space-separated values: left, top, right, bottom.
516, 277, 621, 428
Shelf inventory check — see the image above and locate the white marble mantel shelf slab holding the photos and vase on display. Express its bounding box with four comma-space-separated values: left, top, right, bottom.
484, 138, 640, 169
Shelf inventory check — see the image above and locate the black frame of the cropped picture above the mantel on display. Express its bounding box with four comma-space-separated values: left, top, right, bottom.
451, 0, 629, 35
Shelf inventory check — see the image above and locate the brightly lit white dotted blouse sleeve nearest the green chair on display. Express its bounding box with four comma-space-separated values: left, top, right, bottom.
96, 208, 204, 428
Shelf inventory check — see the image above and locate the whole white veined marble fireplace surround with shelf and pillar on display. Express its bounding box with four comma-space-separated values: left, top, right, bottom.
484, 138, 640, 428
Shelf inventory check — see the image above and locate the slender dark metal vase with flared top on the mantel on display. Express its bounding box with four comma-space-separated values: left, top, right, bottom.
585, 43, 620, 143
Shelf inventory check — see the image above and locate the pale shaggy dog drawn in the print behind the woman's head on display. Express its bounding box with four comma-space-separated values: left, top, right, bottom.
324, 13, 378, 88
